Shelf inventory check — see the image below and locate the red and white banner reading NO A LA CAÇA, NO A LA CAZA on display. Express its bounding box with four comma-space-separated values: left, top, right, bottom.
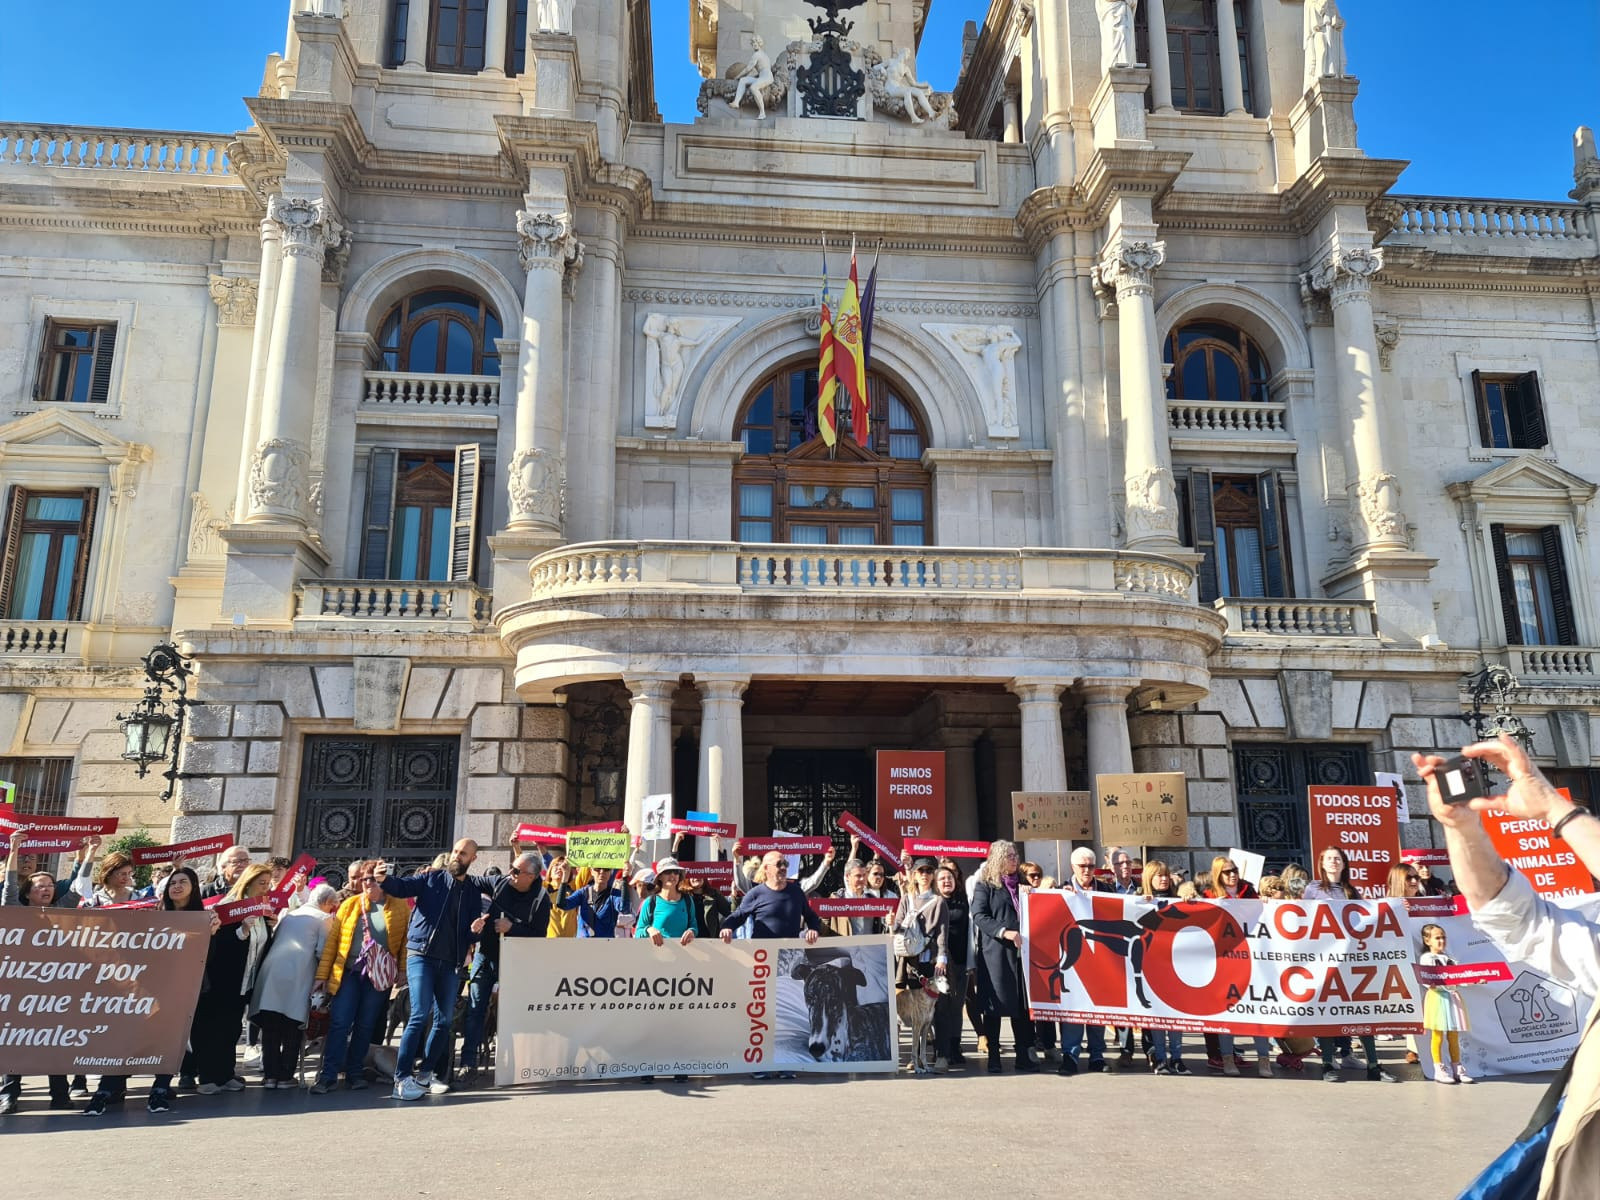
1022, 891, 1422, 1037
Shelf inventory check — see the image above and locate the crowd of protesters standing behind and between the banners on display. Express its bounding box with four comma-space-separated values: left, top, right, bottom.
0, 748, 1574, 1115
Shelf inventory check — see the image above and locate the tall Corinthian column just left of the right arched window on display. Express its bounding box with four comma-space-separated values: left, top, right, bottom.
1096, 234, 1178, 550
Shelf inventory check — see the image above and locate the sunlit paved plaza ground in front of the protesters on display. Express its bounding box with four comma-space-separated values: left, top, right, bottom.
0, 1043, 1549, 1200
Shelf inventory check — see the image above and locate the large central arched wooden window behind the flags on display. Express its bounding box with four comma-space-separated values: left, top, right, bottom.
733, 360, 933, 546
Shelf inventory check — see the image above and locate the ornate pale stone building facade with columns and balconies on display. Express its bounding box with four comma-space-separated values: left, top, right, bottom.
0, 0, 1600, 883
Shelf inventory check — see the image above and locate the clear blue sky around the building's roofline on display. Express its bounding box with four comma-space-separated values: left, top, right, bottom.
0, 0, 1600, 200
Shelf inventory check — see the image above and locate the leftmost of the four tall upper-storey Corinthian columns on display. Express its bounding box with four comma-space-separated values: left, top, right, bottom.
243, 194, 346, 530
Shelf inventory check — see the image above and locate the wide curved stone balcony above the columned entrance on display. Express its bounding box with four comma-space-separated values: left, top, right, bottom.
496, 541, 1224, 702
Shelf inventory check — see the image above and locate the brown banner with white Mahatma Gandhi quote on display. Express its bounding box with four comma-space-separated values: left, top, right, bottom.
0, 906, 211, 1075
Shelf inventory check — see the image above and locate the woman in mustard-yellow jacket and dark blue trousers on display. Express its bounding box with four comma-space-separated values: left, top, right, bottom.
312, 861, 411, 1096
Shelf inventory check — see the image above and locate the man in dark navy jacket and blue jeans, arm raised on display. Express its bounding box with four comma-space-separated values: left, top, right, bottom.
373, 837, 493, 1101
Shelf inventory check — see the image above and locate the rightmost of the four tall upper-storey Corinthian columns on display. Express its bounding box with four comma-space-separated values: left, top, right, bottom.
1301, 246, 1410, 552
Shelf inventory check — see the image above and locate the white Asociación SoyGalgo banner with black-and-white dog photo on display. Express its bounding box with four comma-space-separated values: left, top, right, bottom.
494, 936, 899, 1086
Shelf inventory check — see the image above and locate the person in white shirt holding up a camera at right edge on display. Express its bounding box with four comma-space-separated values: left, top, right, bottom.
1411, 736, 1600, 1200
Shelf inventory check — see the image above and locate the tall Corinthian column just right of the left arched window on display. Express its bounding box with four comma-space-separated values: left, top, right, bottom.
506, 211, 582, 541
